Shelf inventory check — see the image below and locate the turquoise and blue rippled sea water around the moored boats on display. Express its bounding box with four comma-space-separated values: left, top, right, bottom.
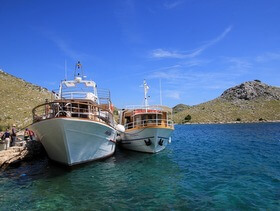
0, 123, 280, 210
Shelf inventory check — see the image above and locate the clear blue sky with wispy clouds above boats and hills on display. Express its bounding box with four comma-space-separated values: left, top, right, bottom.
0, 0, 280, 108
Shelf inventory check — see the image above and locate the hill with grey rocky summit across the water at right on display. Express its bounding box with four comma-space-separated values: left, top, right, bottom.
174, 80, 280, 123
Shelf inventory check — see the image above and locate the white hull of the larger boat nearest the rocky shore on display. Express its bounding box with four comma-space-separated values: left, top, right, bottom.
31, 118, 116, 166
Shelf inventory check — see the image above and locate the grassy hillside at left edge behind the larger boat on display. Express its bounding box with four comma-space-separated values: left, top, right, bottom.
0, 70, 52, 131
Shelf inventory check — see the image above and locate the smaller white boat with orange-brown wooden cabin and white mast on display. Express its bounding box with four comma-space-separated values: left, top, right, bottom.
117, 81, 174, 153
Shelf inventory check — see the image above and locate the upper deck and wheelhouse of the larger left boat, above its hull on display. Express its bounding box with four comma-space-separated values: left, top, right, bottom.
32, 76, 114, 126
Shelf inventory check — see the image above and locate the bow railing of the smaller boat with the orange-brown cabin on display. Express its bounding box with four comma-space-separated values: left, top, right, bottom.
125, 119, 174, 129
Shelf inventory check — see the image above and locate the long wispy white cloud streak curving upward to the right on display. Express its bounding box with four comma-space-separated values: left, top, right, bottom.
151, 26, 232, 59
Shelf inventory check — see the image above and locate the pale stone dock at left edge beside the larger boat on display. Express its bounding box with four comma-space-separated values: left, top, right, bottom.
0, 141, 46, 169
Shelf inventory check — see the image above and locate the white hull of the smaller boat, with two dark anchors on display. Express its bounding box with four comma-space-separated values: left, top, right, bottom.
120, 128, 173, 153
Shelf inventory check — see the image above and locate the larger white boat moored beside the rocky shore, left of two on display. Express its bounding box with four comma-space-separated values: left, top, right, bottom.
31, 62, 116, 166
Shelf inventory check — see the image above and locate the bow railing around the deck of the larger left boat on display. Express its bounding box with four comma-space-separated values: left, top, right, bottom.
32, 100, 114, 125
